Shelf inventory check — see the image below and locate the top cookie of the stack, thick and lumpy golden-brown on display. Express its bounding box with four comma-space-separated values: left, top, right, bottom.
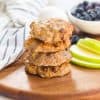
30, 18, 73, 44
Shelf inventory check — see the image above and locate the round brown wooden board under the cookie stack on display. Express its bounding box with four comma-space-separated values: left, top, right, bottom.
0, 64, 100, 100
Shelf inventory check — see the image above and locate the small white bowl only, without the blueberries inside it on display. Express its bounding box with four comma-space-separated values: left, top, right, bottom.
68, 7, 100, 35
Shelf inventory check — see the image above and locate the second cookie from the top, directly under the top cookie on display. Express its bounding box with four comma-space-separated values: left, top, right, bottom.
25, 37, 70, 53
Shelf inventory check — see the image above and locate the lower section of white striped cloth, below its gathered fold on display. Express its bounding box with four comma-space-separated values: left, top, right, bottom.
0, 27, 25, 70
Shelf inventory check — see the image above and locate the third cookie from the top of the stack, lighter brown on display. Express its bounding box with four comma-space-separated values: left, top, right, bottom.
28, 50, 71, 67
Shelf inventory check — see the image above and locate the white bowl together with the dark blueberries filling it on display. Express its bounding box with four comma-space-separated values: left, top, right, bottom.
68, 1, 100, 35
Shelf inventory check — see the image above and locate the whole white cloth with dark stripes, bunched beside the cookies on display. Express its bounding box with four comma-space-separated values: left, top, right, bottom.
0, 0, 47, 70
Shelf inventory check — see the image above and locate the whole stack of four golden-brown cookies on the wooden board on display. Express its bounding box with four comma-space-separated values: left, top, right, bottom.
25, 19, 73, 78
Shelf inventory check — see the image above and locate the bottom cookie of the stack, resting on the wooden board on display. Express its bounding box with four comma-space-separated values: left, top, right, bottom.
25, 63, 70, 78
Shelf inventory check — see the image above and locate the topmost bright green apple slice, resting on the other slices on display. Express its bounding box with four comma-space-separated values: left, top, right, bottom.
77, 39, 100, 54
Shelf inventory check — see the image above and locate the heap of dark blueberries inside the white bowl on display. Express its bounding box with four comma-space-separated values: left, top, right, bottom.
72, 1, 100, 21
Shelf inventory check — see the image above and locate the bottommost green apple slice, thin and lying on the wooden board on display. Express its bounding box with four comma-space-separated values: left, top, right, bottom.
71, 57, 100, 69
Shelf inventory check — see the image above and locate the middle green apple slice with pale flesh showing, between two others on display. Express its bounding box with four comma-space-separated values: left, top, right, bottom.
70, 45, 100, 63
